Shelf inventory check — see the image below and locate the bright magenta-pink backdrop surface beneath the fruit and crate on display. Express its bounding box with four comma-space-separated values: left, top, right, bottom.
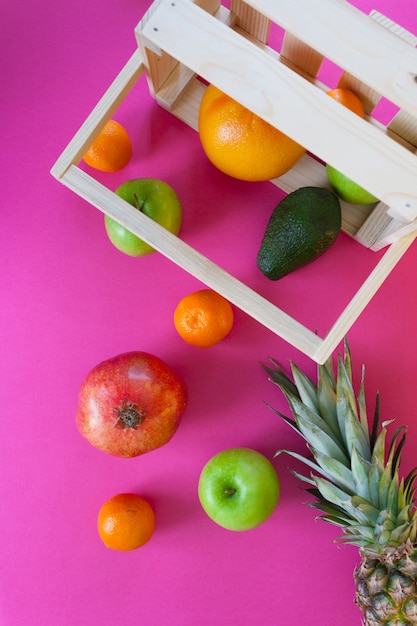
0, 0, 417, 626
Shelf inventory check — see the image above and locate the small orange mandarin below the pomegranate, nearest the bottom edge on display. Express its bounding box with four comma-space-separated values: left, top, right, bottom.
97, 493, 155, 550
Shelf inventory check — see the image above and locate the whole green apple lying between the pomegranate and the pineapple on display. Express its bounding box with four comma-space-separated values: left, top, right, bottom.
198, 448, 280, 531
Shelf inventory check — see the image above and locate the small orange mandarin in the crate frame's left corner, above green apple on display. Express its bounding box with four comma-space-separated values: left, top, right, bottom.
83, 120, 132, 172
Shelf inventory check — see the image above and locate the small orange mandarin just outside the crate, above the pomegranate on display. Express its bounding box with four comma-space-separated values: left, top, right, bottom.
174, 289, 234, 348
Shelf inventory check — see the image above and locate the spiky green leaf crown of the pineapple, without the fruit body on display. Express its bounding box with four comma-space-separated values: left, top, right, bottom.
264, 340, 417, 553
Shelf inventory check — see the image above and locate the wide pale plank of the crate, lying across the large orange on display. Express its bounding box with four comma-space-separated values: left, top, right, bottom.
140, 0, 417, 221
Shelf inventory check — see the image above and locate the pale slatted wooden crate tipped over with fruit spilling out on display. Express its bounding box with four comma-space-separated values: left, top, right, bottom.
51, 0, 417, 363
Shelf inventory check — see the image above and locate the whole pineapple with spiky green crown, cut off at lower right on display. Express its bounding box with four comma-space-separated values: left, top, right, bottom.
264, 340, 417, 626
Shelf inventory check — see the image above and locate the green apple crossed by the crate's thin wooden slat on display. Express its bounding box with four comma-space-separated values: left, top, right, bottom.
104, 178, 182, 257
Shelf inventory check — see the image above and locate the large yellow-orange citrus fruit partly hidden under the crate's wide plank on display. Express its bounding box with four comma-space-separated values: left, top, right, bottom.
198, 85, 305, 181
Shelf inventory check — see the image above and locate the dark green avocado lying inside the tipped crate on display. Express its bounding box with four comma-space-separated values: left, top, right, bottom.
257, 187, 342, 280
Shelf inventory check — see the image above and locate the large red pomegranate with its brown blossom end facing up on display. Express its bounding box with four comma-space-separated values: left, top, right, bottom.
76, 352, 187, 457
